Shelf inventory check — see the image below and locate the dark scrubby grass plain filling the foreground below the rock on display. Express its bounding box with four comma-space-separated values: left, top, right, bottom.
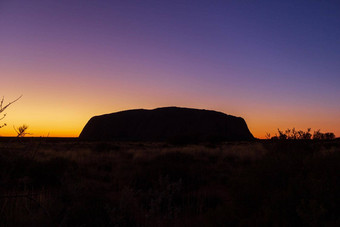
0, 138, 340, 226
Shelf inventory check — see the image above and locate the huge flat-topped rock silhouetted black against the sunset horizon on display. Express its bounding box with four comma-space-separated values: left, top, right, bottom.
79, 107, 254, 142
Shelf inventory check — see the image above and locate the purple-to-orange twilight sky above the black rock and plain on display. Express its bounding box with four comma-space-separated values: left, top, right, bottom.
0, 0, 340, 138
